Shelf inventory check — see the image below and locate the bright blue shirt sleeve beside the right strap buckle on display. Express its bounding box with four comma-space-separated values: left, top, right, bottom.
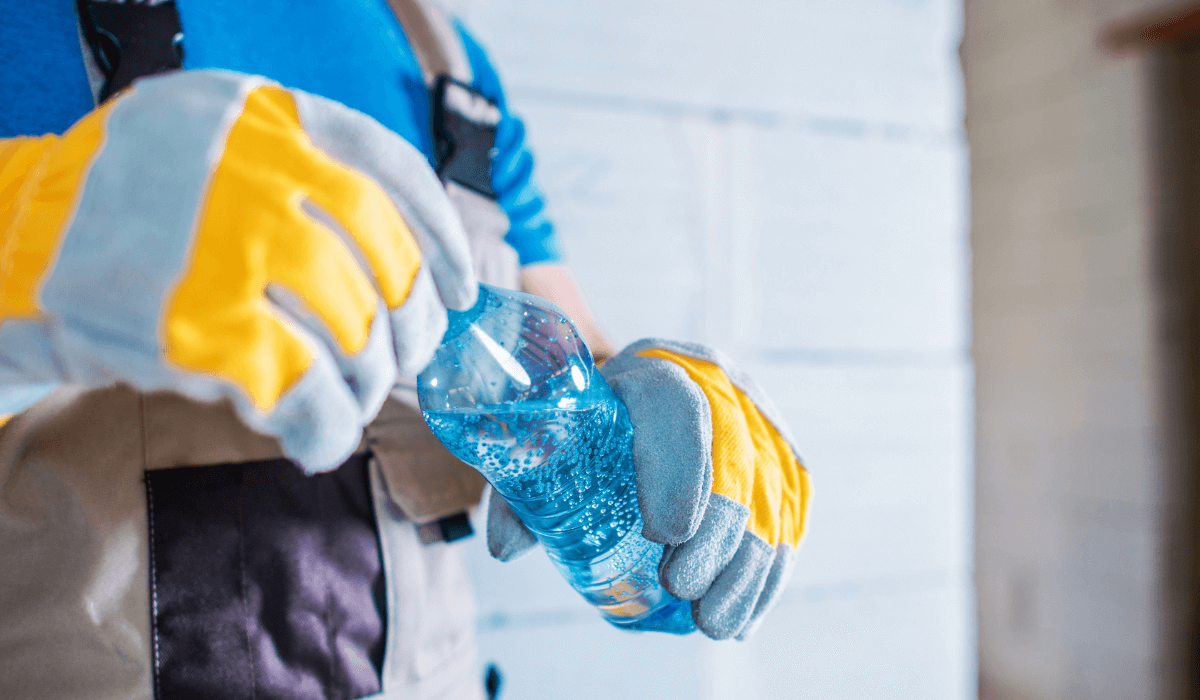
457, 23, 563, 265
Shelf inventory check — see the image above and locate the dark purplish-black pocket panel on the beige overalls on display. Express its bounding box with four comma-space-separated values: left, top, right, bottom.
145, 455, 386, 700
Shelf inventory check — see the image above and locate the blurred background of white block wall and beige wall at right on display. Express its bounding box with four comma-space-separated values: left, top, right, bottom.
446, 0, 1200, 700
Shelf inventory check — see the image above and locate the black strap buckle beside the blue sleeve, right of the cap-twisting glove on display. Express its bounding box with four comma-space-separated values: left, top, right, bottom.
433, 76, 500, 199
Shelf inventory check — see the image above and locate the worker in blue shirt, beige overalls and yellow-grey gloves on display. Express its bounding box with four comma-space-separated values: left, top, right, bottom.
0, 0, 809, 699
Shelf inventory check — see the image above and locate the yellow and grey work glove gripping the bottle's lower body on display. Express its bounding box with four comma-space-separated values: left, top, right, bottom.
487, 339, 811, 639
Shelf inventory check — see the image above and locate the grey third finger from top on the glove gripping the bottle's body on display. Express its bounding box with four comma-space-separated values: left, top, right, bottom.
691, 532, 775, 639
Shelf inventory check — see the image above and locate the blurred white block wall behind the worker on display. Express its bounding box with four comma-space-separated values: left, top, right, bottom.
446, 0, 974, 700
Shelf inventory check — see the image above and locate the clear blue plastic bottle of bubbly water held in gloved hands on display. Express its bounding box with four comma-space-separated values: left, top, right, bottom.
418, 285, 696, 634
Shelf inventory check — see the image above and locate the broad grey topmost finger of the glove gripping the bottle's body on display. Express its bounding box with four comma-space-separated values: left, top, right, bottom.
601, 352, 713, 544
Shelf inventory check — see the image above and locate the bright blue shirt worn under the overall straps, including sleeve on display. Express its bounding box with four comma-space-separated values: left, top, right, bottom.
0, 0, 562, 264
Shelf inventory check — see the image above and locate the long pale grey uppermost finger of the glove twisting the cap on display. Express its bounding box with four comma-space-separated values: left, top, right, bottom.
293, 90, 479, 311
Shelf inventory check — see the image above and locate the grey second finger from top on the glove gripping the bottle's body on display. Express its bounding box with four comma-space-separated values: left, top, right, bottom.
659, 493, 750, 600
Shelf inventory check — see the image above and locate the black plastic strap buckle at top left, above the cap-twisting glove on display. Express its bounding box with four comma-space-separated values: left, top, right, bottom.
76, 0, 184, 102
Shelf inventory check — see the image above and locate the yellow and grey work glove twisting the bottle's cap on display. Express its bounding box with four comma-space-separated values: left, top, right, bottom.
0, 71, 478, 471
